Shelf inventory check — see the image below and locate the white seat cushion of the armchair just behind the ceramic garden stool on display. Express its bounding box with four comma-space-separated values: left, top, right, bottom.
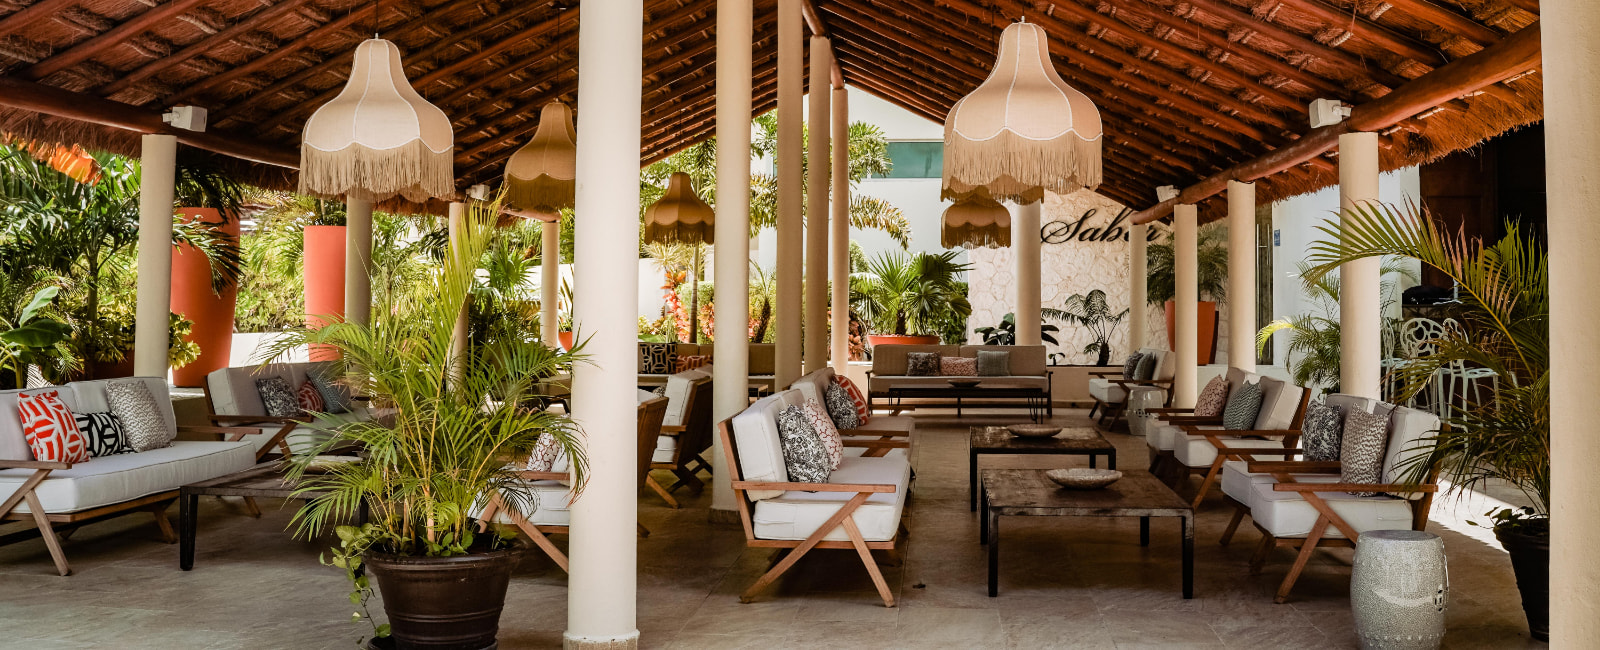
1250, 474, 1411, 538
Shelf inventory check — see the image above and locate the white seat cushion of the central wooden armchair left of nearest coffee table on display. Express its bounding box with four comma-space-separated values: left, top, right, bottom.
750, 455, 910, 541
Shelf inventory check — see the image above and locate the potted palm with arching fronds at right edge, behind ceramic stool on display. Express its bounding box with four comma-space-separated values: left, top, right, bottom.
1307, 207, 1550, 639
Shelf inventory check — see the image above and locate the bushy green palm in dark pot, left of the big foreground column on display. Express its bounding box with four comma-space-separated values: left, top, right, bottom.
272, 203, 586, 648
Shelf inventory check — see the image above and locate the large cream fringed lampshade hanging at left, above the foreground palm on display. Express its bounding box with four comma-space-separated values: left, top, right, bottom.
299, 38, 456, 202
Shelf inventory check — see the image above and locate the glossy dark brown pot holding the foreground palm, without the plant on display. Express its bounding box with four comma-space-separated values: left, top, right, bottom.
365, 546, 526, 650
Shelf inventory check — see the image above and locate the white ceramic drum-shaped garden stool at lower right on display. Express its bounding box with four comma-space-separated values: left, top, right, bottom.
1350, 530, 1450, 650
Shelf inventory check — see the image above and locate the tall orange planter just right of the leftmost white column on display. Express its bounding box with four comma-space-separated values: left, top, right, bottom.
171, 208, 238, 387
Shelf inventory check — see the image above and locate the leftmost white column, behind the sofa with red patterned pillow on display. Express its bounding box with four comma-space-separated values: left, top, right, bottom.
133, 134, 178, 379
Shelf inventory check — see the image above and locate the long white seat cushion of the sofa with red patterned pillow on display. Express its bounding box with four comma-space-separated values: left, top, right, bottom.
0, 440, 256, 512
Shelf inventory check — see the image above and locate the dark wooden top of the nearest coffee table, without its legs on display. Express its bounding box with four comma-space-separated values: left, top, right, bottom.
982, 469, 1194, 517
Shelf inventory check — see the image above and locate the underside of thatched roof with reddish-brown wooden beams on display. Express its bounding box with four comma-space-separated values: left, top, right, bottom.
0, 0, 1542, 217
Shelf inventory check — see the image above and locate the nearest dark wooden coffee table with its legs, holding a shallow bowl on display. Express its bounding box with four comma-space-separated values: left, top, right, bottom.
979, 469, 1195, 599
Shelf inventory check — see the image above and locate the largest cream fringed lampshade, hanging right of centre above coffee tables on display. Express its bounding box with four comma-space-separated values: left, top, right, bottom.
941, 22, 1101, 203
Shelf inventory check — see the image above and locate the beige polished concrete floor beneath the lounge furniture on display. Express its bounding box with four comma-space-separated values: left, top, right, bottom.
0, 411, 1544, 650
